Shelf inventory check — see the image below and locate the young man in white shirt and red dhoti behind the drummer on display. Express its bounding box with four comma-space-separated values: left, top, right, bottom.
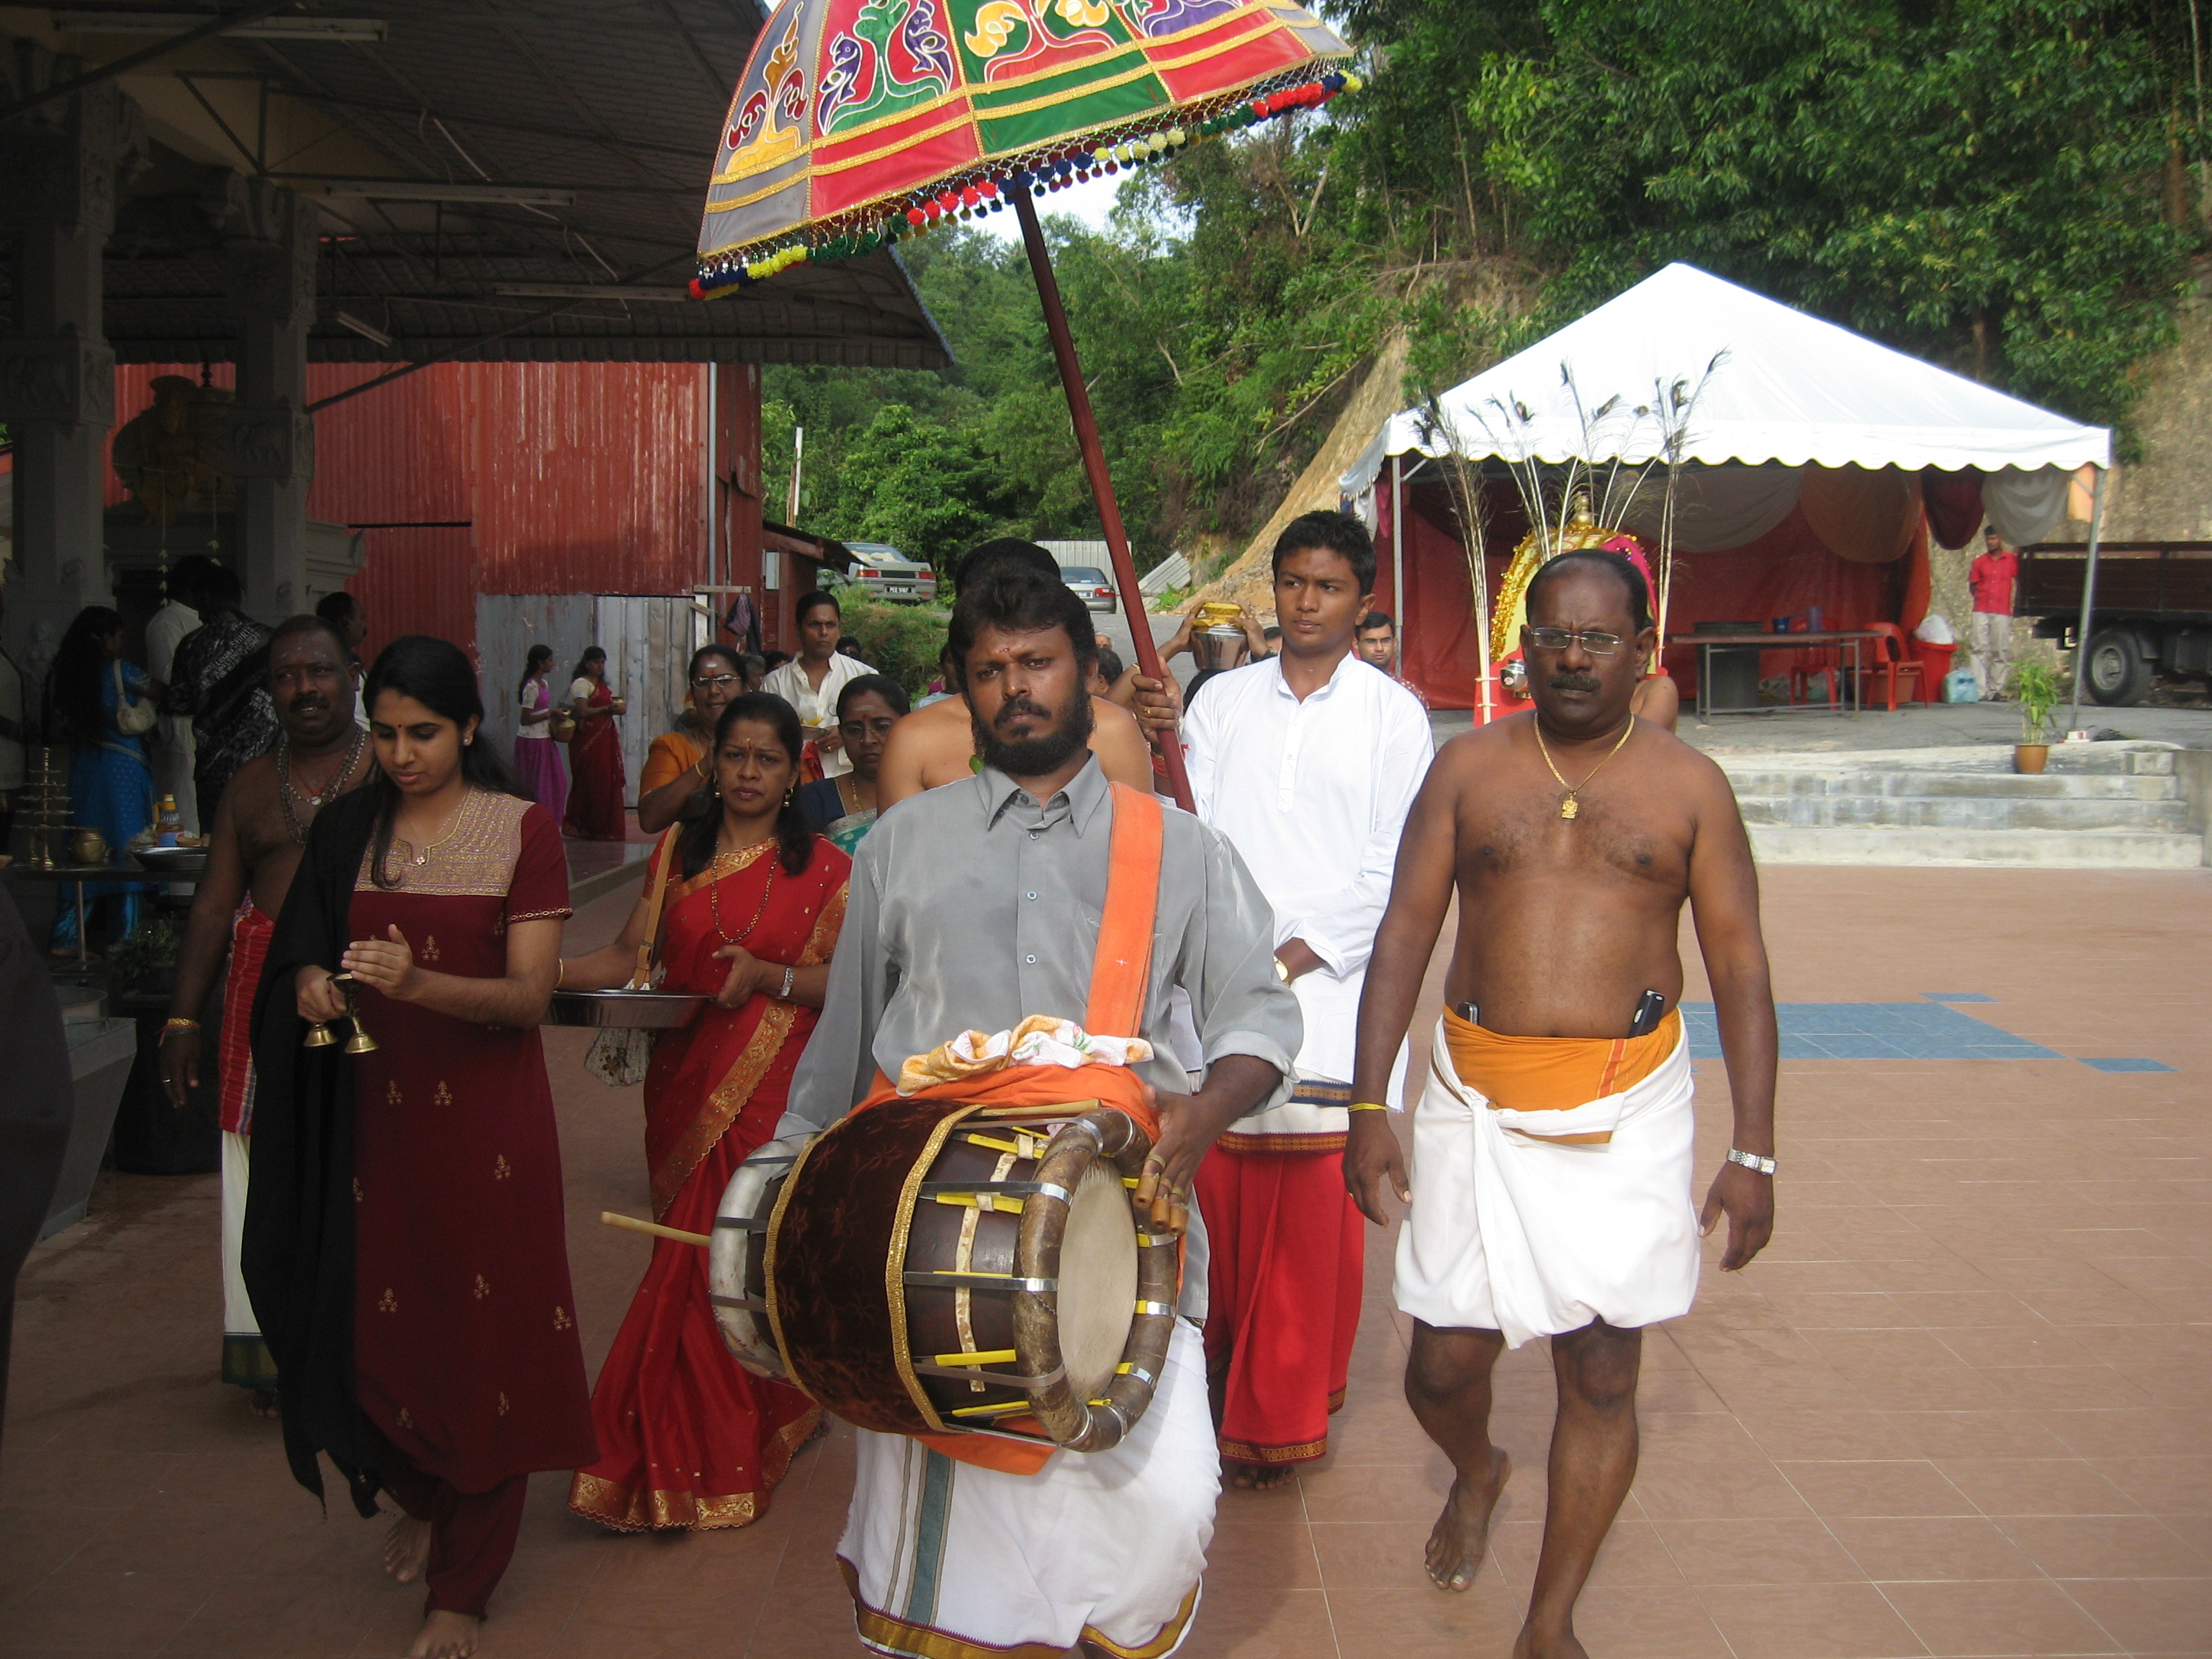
1184, 513, 1434, 1488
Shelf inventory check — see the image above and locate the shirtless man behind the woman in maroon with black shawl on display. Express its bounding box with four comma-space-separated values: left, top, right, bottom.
161, 617, 376, 1416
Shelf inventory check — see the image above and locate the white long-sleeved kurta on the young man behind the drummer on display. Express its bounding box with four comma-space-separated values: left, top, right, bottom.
1184, 652, 1436, 1135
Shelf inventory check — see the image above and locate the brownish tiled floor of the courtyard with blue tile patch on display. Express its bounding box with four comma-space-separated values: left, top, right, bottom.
0, 869, 2212, 1659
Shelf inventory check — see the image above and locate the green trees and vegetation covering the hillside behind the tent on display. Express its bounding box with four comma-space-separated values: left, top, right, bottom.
768, 0, 2212, 584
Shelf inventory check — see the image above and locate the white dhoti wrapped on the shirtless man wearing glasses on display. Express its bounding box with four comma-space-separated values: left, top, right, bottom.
1395, 1022, 1699, 1347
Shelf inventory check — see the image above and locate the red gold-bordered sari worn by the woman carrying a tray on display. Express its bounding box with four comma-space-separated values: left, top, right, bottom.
569, 838, 852, 1533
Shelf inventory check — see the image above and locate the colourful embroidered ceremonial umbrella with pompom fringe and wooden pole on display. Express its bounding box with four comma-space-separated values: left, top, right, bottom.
693, 0, 1356, 807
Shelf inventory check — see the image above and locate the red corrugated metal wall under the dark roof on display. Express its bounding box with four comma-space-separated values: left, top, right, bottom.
106, 363, 716, 667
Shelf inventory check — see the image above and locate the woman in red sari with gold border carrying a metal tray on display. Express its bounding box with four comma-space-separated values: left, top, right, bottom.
562, 693, 852, 1533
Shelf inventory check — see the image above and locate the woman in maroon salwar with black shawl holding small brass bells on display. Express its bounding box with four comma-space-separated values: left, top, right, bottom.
248, 635, 597, 1659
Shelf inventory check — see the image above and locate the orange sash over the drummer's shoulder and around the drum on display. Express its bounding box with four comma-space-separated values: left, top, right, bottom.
854, 783, 1166, 1475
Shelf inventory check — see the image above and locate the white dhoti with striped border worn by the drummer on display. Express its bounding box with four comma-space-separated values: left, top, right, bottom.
836, 1318, 1221, 1659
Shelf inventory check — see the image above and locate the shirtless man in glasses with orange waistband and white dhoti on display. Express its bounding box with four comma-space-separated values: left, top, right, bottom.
1345, 551, 1776, 1659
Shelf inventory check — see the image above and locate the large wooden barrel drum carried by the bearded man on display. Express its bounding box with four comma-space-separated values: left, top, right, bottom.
710, 1102, 1179, 1451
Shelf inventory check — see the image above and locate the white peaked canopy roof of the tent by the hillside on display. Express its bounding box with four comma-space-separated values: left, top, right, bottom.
1341, 266, 2113, 551
